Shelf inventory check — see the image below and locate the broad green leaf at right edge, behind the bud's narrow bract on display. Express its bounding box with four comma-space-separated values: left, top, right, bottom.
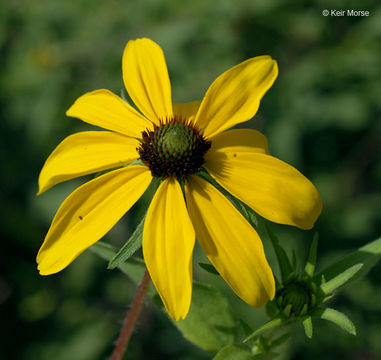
315, 238, 381, 284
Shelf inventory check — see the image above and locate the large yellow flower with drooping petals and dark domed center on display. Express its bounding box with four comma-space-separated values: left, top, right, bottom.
37, 39, 321, 320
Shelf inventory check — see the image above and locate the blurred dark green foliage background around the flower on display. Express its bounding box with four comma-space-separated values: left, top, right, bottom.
0, 0, 381, 360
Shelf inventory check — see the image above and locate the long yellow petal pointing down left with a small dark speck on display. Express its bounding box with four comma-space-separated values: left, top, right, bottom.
37, 166, 152, 275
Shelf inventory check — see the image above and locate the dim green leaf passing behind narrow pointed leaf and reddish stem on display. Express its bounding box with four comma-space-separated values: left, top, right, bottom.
89, 241, 157, 297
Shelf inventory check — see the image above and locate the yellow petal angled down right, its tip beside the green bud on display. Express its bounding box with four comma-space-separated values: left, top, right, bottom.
185, 176, 275, 307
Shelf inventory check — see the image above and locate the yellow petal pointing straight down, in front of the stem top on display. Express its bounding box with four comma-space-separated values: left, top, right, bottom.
143, 178, 195, 321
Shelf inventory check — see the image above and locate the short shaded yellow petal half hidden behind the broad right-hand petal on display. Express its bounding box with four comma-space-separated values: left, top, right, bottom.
209, 129, 269, 156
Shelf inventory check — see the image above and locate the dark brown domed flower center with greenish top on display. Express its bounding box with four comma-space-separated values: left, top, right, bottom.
137, 117, 211, 178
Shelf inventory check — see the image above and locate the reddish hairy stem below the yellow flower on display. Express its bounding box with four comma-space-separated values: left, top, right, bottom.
110, 269, 150, 360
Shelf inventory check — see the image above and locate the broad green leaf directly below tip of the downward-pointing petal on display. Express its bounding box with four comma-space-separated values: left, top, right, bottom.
174, 282, 236, 353
